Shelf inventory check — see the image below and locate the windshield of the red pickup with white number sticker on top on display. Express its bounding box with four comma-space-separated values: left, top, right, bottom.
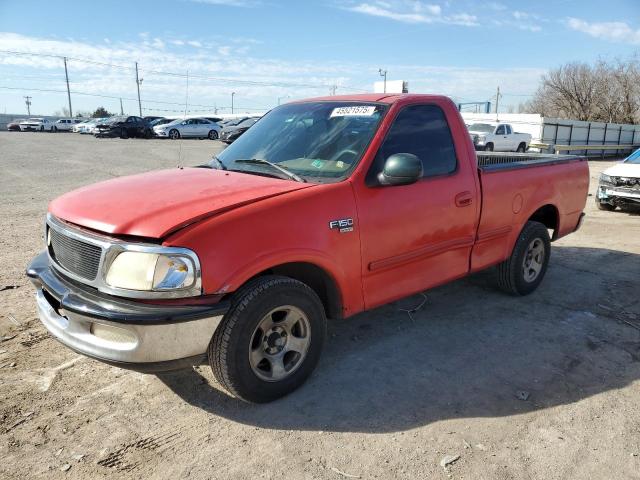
211, 102, 387, 180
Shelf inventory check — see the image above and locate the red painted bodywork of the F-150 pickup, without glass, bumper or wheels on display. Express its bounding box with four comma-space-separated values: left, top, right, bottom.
50, 95, 589, 316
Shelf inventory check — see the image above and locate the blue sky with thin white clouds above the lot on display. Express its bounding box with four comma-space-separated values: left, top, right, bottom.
0, 0, 640, 114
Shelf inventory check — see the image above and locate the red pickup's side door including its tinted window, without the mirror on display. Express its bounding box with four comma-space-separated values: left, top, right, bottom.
356, 104, 478, 308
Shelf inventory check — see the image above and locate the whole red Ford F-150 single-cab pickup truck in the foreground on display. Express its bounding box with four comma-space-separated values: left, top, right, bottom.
27, 94, 589, 402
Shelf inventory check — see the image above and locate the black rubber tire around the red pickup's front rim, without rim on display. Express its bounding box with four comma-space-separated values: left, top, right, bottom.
208, 276, 326, 403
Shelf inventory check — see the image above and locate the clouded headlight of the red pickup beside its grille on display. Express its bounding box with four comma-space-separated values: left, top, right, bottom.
105, 251, 199, 295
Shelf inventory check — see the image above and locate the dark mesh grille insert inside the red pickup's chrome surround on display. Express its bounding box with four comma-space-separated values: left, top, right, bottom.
49, 227, 102, 281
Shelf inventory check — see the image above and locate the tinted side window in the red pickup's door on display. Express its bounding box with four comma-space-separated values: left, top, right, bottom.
369, 105, 457, 177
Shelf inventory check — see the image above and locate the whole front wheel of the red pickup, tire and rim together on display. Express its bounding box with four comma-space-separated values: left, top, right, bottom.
208, 276, 326, 403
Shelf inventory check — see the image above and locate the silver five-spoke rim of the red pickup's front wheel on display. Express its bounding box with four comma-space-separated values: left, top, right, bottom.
249, 305, 311, 382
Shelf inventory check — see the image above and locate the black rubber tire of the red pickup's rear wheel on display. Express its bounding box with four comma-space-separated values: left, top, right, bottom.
497, 221, 551, 295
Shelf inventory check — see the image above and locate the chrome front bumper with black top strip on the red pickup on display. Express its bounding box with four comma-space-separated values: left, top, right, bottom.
27, 252, 229, 372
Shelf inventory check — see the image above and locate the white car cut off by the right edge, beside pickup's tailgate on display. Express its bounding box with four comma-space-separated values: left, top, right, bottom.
596, 149, 640, 211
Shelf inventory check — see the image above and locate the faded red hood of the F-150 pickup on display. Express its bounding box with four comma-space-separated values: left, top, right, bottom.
49, 168, 313, 239
